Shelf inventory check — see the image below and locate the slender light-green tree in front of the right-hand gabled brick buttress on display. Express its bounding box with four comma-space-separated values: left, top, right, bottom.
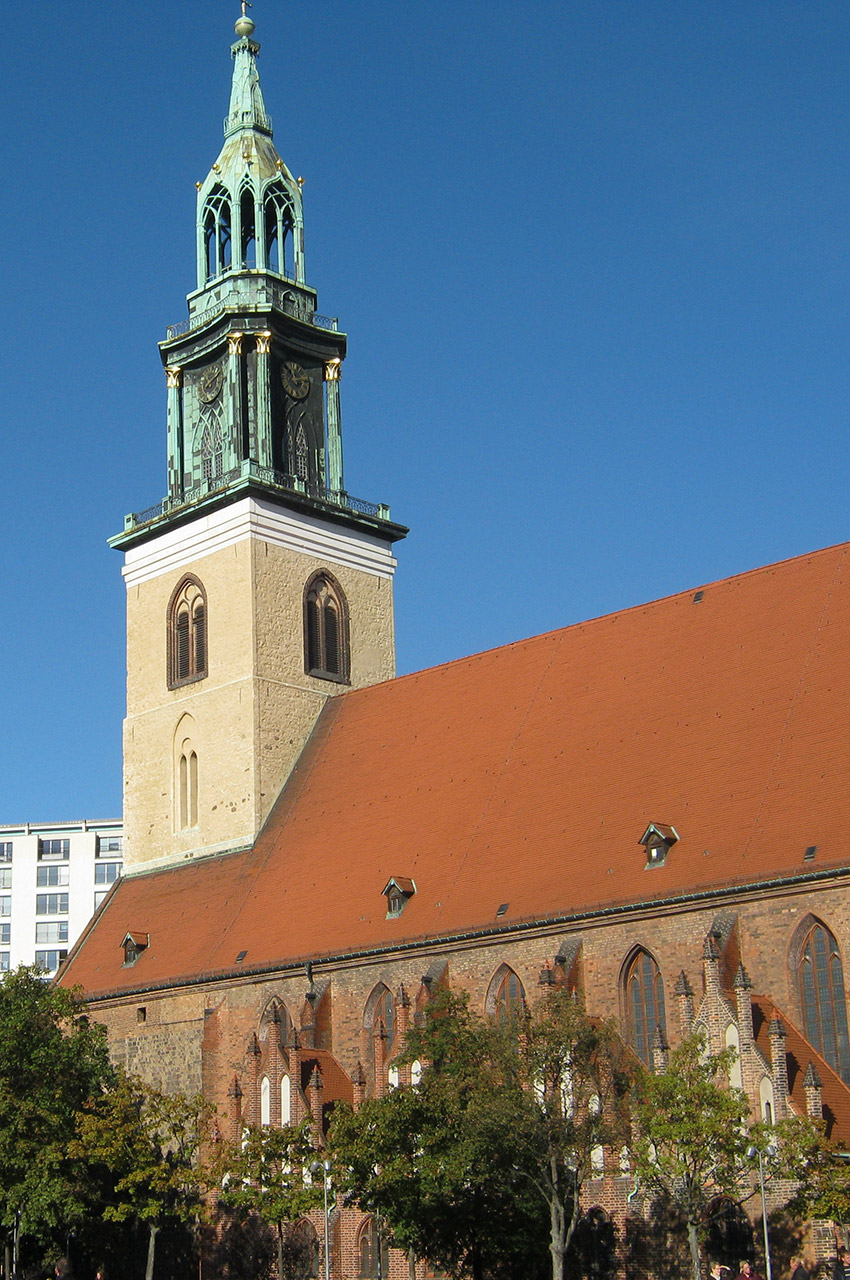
632, 1034, 751, 1280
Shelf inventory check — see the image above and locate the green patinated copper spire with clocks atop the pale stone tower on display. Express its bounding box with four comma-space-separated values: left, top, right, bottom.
110, 6, 407, 548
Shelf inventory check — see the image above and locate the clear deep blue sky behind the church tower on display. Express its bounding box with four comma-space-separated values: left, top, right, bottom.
0, 0, 850, 822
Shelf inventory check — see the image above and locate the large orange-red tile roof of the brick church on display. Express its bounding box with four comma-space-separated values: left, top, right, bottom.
63, 545, 850, 993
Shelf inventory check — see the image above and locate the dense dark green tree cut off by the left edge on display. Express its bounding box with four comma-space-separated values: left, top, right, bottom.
0, 968, 113, 1264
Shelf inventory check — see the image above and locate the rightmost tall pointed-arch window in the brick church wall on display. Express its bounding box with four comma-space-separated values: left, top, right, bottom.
798, 922, 850, 1083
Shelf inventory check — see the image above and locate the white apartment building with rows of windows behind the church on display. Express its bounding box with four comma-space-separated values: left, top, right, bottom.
0, 820, 123, 977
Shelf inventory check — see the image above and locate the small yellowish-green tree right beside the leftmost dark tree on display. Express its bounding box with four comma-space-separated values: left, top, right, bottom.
77, 1075, 210, 1280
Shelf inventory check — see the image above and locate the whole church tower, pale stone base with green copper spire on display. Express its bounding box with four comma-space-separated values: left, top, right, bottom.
111, 4, 407, 873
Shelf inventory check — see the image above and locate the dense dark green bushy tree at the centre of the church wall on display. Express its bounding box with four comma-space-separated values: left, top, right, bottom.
329, 992, 547, 1280
